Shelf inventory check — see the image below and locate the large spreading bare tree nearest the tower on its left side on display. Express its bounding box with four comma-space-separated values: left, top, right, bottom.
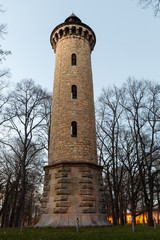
1, 80, 49, 226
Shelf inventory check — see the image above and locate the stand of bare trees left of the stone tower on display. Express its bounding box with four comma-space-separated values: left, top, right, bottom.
0, 79, 52, 227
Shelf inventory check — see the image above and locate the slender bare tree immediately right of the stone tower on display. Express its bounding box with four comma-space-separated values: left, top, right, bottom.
97, 87, 124, 225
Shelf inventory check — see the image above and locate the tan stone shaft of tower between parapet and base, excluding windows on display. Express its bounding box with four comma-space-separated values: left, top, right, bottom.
49, 35, 97, 164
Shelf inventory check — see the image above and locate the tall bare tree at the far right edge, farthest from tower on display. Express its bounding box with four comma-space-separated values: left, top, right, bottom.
123, 79, 160, 225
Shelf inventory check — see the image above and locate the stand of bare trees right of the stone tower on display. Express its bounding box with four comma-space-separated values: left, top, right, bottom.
96, 78, 160, 225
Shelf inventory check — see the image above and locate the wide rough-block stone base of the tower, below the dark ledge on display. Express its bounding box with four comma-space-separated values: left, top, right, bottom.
36, 162, 109, 227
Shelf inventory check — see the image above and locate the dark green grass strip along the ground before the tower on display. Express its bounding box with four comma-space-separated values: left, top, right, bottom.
0, 225, 160, 240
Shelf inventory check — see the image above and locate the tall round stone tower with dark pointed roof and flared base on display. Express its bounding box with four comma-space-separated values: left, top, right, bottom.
37, 14, 107, 227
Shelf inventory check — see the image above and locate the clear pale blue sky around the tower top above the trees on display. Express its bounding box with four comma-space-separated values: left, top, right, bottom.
0, 0, 160, 99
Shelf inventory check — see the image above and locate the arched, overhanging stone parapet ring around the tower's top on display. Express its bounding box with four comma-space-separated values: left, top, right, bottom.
50, 21, 96, 53
